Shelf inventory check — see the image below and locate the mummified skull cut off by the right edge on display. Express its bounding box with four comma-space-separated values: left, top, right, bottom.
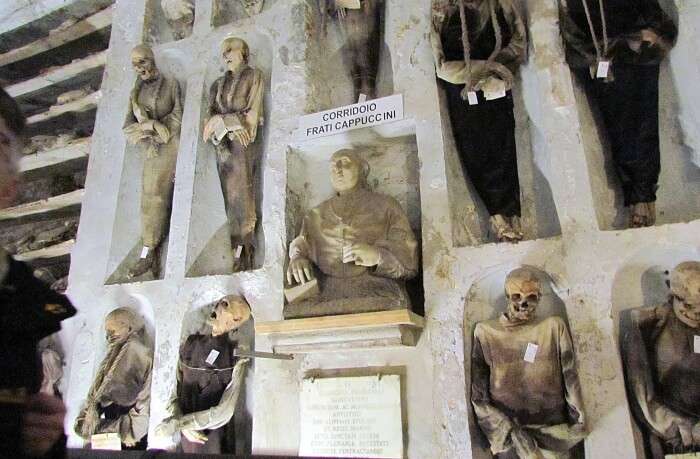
671, 261, 700, 328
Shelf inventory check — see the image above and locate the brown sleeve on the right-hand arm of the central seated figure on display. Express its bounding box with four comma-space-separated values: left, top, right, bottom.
373, 199, 418, 279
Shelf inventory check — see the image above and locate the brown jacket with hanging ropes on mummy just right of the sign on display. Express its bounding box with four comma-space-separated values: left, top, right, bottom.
430, 0, 527, 89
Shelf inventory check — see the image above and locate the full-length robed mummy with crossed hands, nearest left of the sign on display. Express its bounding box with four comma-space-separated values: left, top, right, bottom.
203, 38, 264, 271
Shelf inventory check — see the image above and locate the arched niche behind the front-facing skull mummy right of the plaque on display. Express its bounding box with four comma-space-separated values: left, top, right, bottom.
464, 264, 584, 459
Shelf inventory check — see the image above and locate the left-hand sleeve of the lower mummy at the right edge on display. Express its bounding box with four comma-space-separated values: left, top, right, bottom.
620, 308, 693, 441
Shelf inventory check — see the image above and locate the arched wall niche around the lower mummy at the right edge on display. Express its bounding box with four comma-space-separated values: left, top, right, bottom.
610, 244, 700, 457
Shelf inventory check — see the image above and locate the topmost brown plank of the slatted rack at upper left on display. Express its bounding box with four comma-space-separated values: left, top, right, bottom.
0, 7, 112, 66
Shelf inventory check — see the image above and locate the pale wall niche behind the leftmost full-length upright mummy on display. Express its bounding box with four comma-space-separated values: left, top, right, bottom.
106, 48, 191, 284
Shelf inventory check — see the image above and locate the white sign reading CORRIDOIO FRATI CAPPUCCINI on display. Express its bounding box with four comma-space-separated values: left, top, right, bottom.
296, 94, 403, 140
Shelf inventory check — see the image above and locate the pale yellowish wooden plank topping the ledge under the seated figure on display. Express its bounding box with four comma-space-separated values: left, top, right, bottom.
255, 309, 425, 335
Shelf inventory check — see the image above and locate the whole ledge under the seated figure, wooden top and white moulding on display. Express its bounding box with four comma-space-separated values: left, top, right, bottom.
255, 309, 425, 354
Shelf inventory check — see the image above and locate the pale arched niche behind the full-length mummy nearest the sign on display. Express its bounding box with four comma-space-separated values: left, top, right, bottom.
185, 28, 272, 277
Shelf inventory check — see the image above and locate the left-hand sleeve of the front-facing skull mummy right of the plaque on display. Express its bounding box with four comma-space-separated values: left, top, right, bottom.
471, 324, 513, 454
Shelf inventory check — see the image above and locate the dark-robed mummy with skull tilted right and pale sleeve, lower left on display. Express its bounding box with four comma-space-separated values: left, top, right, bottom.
156, 295, 251, 454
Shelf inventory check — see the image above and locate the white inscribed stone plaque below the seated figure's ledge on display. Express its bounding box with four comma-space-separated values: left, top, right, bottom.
299, 375, 403, 458
